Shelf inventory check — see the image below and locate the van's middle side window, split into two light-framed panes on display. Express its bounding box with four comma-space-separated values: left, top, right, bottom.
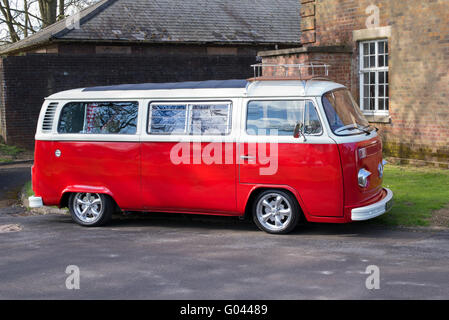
148, 103, 231, 135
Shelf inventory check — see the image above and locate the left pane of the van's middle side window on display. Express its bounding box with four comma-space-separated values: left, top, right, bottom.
150, 105, 187, 134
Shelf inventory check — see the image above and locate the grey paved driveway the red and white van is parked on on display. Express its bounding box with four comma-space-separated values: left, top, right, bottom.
0, 210, 449, 299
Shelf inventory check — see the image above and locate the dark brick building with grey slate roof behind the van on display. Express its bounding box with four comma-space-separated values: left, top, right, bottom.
0, 0, 301, 148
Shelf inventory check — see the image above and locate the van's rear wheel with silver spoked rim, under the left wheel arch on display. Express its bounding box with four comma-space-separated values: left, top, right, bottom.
69, 193, 114, 227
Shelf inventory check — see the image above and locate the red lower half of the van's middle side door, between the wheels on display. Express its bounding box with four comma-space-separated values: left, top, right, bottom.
142, 141, 237, 215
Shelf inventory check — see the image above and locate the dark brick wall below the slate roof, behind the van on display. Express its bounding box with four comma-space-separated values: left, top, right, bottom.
0, 54, 256, 148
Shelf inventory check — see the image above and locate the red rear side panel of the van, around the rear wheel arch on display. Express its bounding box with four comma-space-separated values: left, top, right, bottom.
33, 141, 142, 210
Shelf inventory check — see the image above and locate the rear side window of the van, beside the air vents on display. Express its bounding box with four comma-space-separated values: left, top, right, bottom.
58, 102, 139, 134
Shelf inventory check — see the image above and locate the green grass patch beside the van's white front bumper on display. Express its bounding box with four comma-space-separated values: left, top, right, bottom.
375, 164, 449, 227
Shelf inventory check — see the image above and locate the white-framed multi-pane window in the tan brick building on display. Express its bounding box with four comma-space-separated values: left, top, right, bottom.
359, 39, 390, 115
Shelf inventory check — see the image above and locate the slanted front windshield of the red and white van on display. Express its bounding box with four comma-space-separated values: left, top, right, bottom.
323, 89, 374, 136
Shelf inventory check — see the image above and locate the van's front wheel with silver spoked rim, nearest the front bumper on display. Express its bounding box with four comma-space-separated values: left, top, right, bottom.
253, 190, 300, 234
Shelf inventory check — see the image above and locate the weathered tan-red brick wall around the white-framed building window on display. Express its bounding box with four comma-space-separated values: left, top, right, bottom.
261, 0, 449, 164
